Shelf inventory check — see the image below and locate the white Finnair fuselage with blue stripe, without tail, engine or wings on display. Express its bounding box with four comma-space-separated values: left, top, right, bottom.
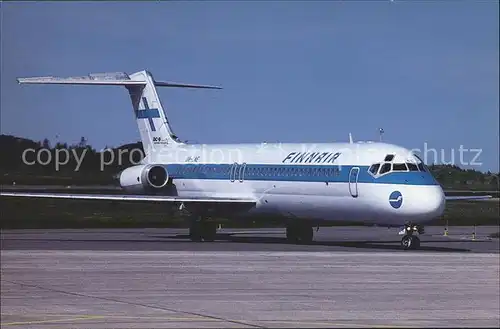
132, 143, 445, 225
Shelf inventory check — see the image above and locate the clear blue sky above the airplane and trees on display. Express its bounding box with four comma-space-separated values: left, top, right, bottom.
1, 0, 499, 171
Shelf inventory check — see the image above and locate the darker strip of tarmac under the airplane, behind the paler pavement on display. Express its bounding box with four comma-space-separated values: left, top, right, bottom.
2, 226, 500, 253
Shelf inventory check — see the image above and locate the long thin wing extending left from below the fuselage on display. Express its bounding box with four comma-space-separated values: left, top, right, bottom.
0, 192, 256, 205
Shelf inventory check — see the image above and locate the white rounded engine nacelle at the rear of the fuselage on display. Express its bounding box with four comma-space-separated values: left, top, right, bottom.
120, 164, 169, 193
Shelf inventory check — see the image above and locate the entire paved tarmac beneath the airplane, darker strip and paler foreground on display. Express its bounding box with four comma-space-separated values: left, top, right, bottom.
1, 227, 500, 328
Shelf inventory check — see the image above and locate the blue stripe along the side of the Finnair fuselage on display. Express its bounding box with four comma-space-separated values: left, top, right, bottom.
162, 163, 439, 185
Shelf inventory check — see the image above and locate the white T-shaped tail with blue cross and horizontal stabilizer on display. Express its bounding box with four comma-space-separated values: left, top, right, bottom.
17, 71, 222, 156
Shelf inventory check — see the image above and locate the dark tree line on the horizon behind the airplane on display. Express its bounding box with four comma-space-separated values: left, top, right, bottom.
0, 135, 499, 190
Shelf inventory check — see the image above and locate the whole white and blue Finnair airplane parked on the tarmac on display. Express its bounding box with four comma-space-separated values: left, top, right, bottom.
0, 70, 491, 250
